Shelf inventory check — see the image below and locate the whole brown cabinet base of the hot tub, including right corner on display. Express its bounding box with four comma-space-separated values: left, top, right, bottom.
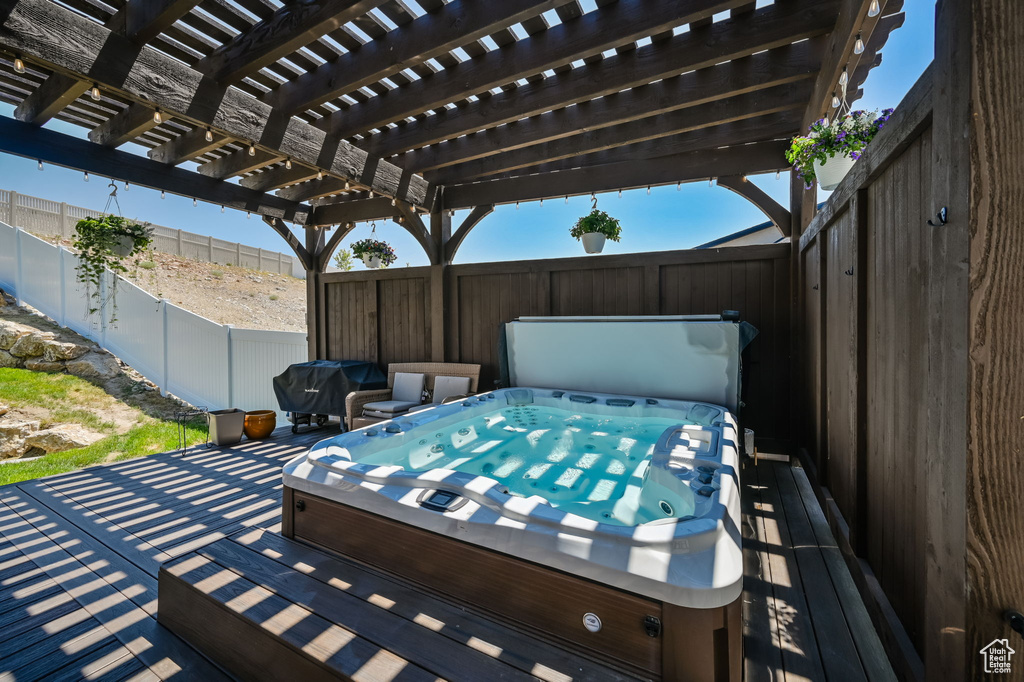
282, 486, 742, 682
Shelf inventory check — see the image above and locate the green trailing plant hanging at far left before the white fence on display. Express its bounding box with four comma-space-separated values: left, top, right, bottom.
72, 215, 153, 324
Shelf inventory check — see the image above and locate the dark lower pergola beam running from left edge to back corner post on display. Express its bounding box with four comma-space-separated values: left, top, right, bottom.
0, 117, 309, 223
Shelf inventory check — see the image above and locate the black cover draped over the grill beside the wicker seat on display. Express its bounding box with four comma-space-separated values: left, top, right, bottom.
273, 360, 387, 417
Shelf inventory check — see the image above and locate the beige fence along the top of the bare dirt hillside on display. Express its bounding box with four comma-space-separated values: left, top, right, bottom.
0, 189, 306, 280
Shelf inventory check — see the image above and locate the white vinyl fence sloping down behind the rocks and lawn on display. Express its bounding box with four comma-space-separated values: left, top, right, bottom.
0, 222, 307, 417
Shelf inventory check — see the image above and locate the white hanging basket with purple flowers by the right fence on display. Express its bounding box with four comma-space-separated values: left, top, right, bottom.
785, 109, 893, 189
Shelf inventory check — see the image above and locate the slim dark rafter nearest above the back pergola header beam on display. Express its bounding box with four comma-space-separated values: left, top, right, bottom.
479, 112, 800, 184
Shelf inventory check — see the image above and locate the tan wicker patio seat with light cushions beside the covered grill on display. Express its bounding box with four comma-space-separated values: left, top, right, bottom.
345, 363, 480, 429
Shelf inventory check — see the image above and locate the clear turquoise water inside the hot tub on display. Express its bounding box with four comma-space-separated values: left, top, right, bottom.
359, 404, 693, 525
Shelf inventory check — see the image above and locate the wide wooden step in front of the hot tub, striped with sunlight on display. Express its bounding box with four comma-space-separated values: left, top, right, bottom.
159, 530, 636, 680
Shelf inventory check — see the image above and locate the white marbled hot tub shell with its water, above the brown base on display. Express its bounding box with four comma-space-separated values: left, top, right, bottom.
284, 387, 742, 608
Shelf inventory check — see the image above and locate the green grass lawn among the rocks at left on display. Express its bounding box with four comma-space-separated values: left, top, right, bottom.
0, 369, 206, 485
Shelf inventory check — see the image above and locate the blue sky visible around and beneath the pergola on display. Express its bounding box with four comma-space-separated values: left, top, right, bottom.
0, 0, 935, 267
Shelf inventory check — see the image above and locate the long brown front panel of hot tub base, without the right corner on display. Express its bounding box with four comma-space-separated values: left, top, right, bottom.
294, 491, 662, 675
